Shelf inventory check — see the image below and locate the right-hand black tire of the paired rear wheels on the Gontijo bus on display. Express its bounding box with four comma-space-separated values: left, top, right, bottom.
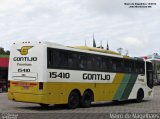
80, 91, 93, 108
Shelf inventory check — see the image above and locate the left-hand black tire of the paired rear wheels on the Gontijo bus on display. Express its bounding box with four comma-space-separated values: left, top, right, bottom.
67, 91, 80, 109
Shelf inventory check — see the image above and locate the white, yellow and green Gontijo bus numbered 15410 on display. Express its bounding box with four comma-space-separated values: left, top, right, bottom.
8, 42, 153, 109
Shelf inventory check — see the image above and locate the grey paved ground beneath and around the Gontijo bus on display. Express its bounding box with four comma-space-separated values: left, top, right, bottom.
0, 86, 160, 119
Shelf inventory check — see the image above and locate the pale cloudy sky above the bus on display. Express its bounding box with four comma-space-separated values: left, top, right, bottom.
0, 0, 160, 56
